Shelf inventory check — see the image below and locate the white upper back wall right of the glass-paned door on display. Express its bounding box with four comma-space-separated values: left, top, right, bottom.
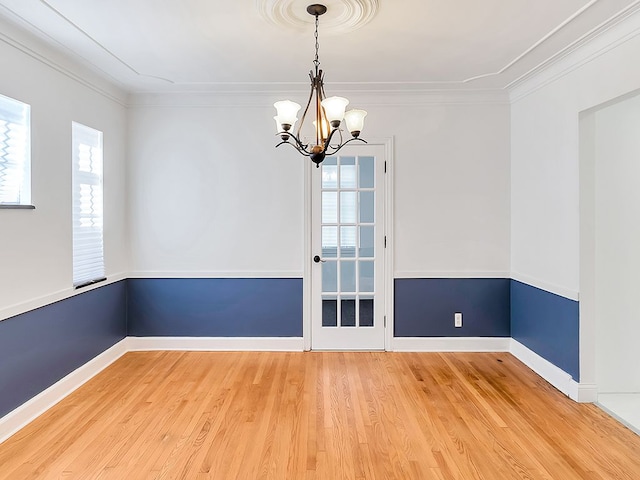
378, 96, 510, 278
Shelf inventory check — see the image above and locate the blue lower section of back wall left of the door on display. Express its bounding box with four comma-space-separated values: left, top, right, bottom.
128, 278, 302, 337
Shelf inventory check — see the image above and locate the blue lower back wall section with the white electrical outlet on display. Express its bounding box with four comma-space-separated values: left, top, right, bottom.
394, 278, 511, 337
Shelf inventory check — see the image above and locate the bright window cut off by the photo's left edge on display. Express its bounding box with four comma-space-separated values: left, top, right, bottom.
0, 95, 31, 207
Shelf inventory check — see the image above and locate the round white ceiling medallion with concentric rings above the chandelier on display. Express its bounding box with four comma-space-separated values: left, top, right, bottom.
256, 0, 379, 33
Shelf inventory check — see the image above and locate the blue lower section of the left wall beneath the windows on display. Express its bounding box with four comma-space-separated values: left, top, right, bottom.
0, 281, 127, 417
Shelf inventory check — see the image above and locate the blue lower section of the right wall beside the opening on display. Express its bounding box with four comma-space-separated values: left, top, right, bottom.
511, 280, 580, 381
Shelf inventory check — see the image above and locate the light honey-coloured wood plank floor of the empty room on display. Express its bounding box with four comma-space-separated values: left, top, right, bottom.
0, 352, 640, 480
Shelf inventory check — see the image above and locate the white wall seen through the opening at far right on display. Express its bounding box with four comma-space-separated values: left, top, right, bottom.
595, 96, 640, 393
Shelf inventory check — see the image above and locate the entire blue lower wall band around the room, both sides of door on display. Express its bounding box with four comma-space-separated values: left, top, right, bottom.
0, 278, 579, 417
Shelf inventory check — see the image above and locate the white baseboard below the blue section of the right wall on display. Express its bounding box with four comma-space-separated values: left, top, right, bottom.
510, 339, 598, 403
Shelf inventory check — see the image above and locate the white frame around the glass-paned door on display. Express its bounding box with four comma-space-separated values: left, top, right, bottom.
302, 137, 394, 351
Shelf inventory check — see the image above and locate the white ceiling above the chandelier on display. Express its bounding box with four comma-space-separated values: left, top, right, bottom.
0, 0, 638, 92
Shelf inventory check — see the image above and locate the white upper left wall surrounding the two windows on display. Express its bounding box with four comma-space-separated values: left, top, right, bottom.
0, 18, 128, 320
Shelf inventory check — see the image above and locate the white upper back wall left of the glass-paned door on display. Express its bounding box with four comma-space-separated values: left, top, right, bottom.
128, 99, 305, 277
